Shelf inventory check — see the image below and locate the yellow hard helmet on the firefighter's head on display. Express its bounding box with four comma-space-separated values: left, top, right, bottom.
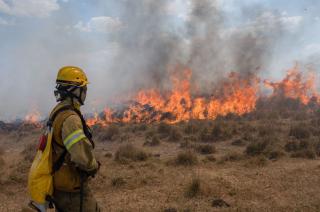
56, 66, 89, 87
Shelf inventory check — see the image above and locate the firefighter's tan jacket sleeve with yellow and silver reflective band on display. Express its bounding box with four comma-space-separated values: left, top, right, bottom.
61, 115, 98, 171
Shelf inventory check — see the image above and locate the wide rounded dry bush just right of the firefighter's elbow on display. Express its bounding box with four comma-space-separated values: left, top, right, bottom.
115, 144, 148, 163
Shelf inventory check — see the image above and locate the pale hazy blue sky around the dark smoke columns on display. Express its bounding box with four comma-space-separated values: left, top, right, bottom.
0, 0, 320, 120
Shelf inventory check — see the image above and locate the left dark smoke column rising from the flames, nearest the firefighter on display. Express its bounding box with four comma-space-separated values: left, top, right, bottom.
107, 0, 183, 93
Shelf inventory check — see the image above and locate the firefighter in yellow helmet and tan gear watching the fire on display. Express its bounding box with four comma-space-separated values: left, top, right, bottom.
51, 66, 100, 212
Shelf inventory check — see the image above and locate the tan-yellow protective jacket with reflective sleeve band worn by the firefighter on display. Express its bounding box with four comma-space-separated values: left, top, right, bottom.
50, 99, 98, 192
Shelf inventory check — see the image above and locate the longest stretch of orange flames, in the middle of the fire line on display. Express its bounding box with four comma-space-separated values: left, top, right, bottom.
88, 69, 259, 126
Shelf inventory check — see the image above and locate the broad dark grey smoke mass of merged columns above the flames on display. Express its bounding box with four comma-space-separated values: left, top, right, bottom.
111, 0, 283, 94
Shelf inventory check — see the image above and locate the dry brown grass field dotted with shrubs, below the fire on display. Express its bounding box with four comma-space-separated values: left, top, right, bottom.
0, 102, 320, 212
